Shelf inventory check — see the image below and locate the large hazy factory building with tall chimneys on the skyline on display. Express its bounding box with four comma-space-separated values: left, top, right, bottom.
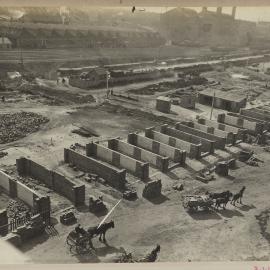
161, 7, 256, 47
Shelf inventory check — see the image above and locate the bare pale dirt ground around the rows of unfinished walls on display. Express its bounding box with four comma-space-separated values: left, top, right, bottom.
0, 55, 270, 263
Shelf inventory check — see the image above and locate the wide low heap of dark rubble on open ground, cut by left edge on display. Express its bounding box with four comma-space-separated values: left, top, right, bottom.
0, 112, 49, 144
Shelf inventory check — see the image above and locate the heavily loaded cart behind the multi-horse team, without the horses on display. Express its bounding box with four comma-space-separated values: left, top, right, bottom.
183, 195, 214, 211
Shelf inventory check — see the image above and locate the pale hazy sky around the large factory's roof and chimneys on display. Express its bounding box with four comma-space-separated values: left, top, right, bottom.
118, 5, 270, 22
